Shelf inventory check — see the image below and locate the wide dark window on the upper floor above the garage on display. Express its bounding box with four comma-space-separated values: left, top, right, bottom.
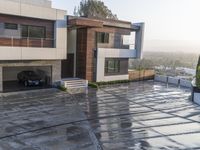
21, 25, 46, 38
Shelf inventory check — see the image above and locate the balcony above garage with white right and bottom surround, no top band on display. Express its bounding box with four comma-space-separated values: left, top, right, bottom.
0, 14, 67, 60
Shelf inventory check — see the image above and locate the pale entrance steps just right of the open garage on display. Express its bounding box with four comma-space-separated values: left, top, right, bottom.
61, 78, 88, 90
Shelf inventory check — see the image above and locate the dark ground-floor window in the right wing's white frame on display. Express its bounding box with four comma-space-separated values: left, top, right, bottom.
105, 59, 120, 74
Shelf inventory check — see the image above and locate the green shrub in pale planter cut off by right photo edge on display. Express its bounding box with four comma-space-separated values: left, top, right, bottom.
192, 56, 200, 105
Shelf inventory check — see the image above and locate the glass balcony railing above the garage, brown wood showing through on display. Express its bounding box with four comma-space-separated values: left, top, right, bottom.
0, 36, 55, 48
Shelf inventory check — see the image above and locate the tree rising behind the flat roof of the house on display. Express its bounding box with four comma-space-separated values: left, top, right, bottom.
74, 0, 117, 19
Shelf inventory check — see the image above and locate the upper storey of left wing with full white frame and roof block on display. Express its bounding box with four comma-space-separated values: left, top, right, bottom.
0, 0, 67, 60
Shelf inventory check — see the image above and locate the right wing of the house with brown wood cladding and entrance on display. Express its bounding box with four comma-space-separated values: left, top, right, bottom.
62, 16, 144, 82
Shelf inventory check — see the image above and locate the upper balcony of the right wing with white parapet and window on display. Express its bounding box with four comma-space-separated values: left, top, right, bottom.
97, 32, 137, 58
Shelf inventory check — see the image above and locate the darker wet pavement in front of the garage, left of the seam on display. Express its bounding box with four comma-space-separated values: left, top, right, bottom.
0, 89, 101, 150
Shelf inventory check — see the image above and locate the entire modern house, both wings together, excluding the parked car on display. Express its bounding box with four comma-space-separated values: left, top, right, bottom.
0, 0, 144, 91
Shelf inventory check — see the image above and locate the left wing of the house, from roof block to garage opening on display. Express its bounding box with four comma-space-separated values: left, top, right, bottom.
0, 0, 67, 91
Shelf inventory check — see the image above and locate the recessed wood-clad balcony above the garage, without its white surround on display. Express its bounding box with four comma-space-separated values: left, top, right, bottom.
0, 18, 55, 48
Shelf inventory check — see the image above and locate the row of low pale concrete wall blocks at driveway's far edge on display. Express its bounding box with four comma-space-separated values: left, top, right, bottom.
154, 75, 192, 88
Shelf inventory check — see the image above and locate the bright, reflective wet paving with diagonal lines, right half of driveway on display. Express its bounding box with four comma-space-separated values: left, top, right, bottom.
74, 81, 200, 150
